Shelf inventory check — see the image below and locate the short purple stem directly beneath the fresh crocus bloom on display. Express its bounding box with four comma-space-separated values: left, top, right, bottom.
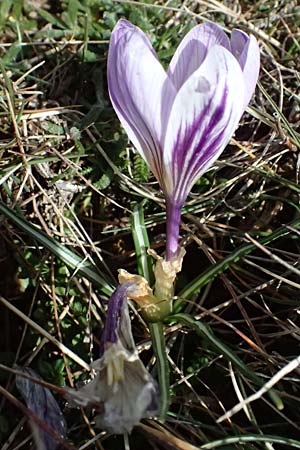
166, 199, 182, 261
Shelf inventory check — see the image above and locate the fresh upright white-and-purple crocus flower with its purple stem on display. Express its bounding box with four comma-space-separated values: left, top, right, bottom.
108, 19, 259, 260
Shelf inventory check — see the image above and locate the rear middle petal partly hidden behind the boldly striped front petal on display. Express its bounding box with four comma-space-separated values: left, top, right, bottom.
168, 23, 230, 90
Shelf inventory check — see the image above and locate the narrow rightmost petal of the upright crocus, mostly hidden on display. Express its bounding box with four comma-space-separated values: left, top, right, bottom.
230, 30, 260, 109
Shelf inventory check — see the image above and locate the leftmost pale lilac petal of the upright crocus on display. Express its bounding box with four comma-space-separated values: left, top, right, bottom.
107, 19, 176, 185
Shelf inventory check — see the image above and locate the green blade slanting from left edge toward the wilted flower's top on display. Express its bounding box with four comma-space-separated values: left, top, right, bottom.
0, 204, 114, 295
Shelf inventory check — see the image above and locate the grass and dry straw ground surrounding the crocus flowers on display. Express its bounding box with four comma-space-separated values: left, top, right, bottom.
0, 0, 300, 450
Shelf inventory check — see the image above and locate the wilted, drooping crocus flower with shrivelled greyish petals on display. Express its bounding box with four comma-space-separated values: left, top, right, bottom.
67, 283, 158, 434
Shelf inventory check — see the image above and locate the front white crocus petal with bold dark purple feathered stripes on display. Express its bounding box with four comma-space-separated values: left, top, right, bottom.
163, 45, 244, 205
